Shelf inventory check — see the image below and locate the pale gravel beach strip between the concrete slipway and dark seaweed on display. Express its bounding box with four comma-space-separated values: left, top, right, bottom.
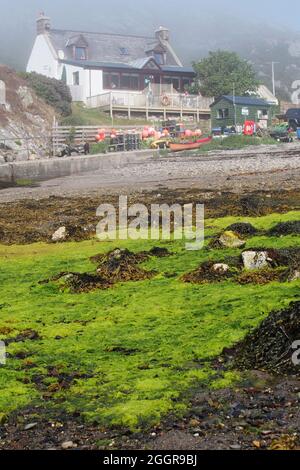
0, 143, 300, 202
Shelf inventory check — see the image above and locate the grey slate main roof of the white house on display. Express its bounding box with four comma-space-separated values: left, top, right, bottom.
48, 29, 178, 66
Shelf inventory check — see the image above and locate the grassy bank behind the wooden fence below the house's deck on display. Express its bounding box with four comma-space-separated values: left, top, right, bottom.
60, 103, 147, 127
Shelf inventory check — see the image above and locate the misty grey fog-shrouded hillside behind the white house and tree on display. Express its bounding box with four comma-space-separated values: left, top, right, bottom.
0, 0, 300, 96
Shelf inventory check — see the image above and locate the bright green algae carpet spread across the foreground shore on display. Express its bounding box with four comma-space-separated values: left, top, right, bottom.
0, 212, 300, 430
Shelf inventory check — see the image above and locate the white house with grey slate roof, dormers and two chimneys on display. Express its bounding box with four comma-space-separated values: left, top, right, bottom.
27, 14, 195, 103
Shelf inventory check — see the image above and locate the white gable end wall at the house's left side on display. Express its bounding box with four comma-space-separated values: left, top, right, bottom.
26, 34, 61, 79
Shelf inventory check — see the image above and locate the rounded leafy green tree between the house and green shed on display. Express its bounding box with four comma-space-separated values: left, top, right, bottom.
192, 50, 259, 97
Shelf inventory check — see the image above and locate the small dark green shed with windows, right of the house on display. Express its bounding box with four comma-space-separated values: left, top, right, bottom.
210, 95, 273, 129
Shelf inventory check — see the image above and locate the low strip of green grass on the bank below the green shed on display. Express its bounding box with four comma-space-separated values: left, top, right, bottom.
199, 135, 278, 152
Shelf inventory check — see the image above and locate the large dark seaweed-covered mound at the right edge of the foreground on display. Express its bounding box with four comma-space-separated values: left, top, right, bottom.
223, 302, 300, 376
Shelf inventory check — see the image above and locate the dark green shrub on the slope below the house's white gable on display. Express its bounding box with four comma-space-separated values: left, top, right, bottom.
22, 72, 72, 116
